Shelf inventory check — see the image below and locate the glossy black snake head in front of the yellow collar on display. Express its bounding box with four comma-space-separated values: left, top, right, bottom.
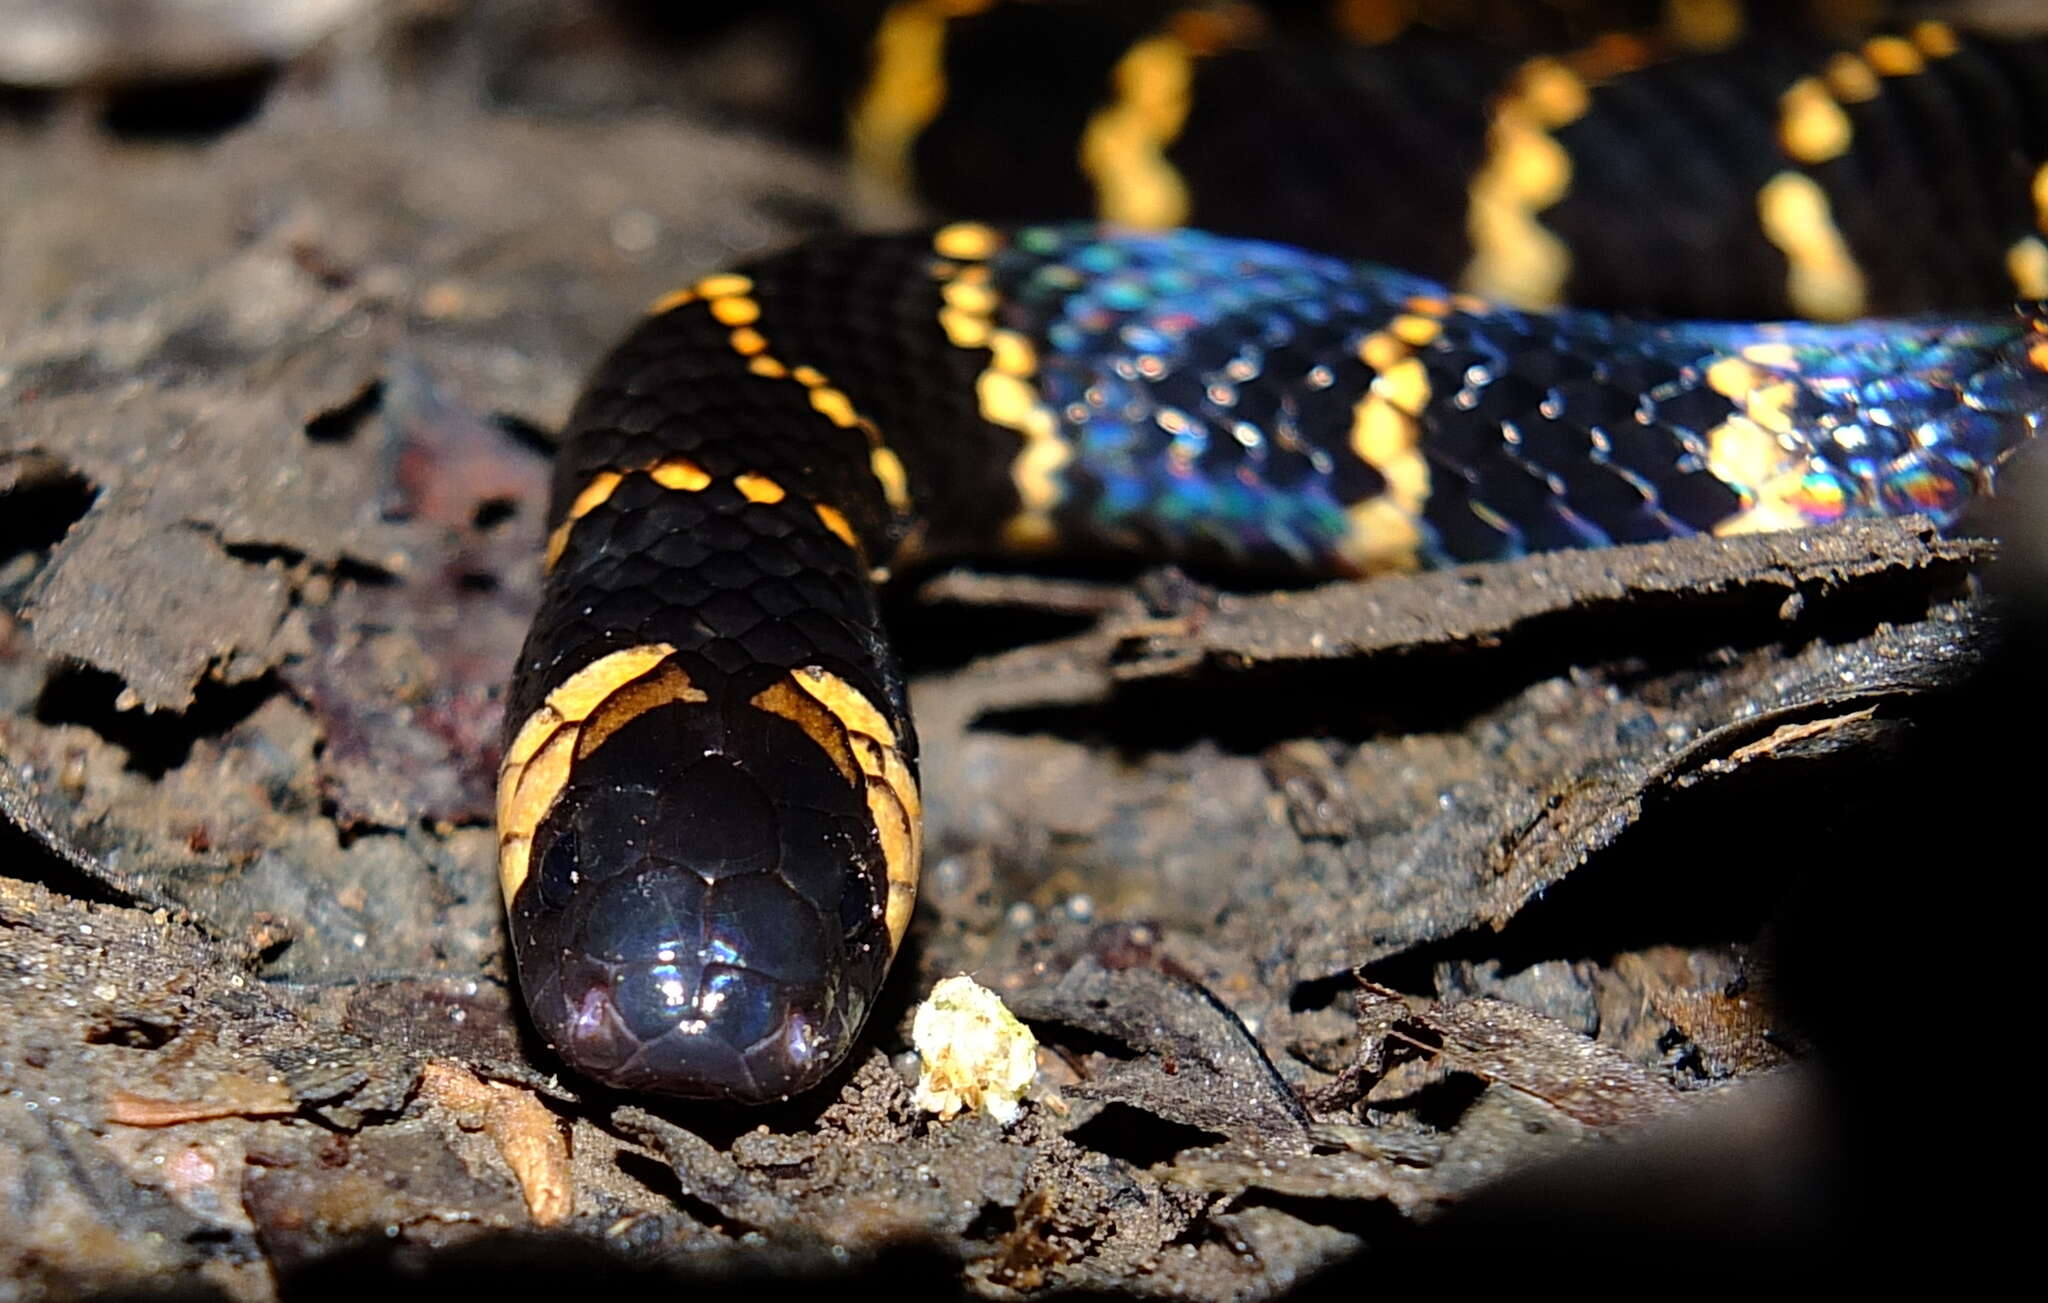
502, 651, 913, 1102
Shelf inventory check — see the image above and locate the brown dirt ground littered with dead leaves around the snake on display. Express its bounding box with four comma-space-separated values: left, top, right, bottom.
0, 0, 2042, 1299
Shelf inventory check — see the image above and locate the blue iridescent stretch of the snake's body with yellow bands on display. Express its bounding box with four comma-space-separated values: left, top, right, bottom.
991, 225, 2048, 570
